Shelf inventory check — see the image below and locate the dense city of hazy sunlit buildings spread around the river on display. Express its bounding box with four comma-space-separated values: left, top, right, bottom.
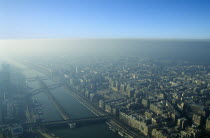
1, 57, 210, 138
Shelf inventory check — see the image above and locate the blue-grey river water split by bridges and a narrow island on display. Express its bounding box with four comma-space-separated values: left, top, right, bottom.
23, 69, 120, 138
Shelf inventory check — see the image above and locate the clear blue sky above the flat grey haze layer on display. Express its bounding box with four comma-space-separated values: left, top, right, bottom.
0, 0, 210, 39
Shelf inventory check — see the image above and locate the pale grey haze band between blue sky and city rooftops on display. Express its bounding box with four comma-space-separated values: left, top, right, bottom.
0, 39, 210, 62
